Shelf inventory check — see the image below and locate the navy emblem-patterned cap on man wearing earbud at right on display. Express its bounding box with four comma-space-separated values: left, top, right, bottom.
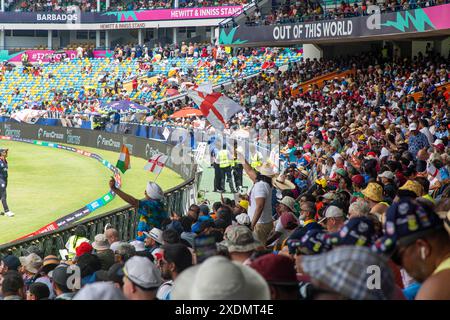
372, 198, 444, 264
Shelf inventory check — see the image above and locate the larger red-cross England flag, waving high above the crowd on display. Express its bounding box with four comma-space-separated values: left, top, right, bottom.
188, 84, 243, 130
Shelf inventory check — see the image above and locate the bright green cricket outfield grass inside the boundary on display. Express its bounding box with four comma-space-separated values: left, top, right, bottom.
0, 141, 183, 244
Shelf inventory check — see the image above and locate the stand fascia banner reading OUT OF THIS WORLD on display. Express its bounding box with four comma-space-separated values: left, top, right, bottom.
219, 4, 450, 46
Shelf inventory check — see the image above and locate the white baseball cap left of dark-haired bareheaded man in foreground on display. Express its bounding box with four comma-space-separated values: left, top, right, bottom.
123, 256, 163, 290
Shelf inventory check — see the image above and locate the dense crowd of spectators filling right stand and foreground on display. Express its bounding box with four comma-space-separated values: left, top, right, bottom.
0, 43, 450, 300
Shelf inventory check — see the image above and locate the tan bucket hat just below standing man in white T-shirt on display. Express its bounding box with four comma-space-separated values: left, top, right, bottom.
220, 225, 261, 252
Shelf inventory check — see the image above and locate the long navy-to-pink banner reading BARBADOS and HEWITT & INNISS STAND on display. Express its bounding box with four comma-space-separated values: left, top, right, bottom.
0, 6, 242, 24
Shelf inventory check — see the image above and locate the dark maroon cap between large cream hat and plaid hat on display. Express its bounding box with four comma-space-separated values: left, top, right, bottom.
250, 253, 298, 286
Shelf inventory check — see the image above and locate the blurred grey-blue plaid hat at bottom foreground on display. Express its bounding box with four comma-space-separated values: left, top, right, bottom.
301, 246, 395, 300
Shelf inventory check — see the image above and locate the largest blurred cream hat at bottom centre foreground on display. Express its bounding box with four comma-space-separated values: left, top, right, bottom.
171, 256, 270, 300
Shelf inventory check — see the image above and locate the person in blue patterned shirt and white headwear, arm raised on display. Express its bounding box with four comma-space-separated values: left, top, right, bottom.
109, 178, 169, 241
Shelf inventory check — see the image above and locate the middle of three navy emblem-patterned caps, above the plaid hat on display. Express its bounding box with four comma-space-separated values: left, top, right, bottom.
329, 217, 375, 247
